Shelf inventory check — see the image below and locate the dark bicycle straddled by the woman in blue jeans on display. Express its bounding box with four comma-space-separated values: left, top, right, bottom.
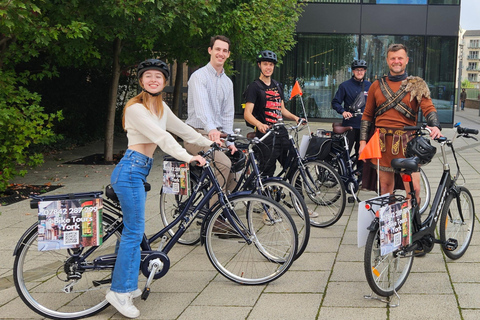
13, 145, 297, 319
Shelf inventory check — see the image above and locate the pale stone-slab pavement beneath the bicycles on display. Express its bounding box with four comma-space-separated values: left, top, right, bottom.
0, 110, 480, 320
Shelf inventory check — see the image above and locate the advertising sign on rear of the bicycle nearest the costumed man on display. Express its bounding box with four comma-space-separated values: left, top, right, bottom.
379, 201, 412, 255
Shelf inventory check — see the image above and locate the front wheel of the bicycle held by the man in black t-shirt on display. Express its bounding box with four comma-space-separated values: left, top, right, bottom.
291, 160, 347, 228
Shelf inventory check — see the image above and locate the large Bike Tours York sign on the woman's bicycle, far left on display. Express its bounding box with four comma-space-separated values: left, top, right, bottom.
38, 198, 103, 251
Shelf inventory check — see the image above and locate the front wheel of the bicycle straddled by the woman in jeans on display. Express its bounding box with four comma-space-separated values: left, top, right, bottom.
203, 194, 297, 285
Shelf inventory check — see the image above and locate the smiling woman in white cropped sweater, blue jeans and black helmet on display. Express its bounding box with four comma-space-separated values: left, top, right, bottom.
106, 59, 213, 318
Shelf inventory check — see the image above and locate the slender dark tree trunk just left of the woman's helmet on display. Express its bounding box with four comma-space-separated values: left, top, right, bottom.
104, 38, 122, 162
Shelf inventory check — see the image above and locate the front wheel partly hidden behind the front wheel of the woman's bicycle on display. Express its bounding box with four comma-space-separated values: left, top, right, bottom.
263, 179, 310, 260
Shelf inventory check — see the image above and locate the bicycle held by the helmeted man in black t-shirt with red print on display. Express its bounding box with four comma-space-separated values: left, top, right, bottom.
278, 119, 346, 228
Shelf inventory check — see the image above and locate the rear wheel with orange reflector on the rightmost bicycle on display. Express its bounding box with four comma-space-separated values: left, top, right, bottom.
364, 230, 413, 297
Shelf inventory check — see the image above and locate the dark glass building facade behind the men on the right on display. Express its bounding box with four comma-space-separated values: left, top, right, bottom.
233, 0, 460, 126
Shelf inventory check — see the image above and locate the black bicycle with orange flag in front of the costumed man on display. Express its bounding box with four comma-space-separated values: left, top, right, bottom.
364, 124, 478, 301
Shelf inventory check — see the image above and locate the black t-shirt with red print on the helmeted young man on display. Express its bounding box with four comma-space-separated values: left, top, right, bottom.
245, 79, 284, 124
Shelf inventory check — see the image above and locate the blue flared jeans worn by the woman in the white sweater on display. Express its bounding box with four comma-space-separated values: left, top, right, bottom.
110, 149, 153, 293
